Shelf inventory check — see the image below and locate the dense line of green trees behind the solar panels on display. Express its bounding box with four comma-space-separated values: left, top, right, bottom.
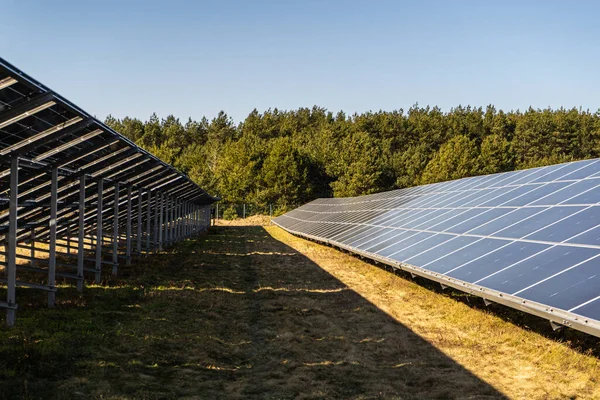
106, 106, 600, 208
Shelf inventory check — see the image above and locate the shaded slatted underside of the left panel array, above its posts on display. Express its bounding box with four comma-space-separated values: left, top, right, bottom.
0, 58, 215, 212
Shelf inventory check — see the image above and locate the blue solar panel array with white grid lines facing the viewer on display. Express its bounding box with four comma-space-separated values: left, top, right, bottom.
274, 159, 600, 336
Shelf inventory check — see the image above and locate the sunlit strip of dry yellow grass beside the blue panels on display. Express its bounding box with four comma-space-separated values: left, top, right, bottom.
266, 226, 600, 399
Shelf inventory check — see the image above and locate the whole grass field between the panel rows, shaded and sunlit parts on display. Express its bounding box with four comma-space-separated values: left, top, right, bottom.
0, 224, 600, 399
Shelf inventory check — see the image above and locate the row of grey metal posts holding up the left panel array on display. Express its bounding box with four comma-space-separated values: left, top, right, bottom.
0, 157, 210, 326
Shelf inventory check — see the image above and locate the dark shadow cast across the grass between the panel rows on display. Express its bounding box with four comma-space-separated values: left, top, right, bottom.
0, 227, 504, 399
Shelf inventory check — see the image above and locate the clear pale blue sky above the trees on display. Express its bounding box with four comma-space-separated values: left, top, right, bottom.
0, 0, 600, 121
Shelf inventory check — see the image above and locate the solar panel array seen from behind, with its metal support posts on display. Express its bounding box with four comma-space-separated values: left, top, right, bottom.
0, 58, 218, 325
